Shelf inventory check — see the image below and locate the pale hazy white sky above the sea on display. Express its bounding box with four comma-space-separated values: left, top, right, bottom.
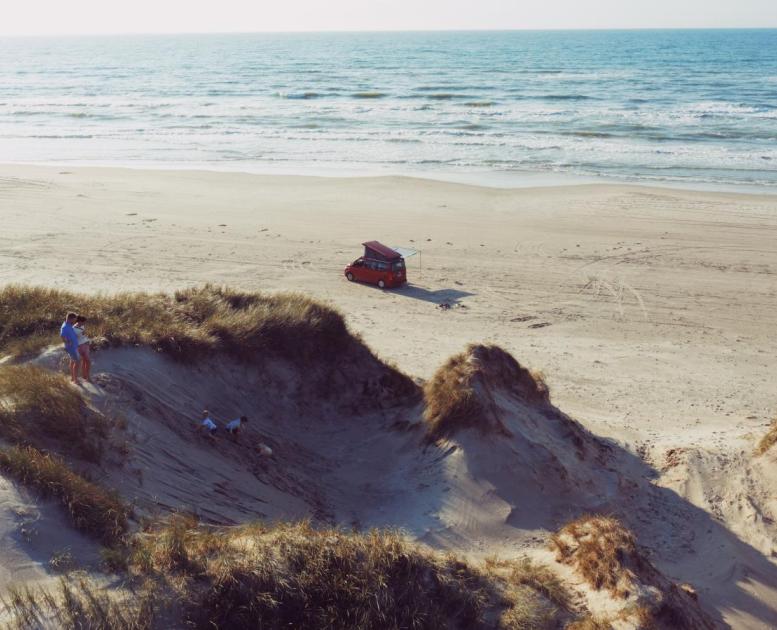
0, 0, 777, 35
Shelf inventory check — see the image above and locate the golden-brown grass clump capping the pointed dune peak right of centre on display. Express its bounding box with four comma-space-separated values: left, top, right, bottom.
424, 345, 549, 440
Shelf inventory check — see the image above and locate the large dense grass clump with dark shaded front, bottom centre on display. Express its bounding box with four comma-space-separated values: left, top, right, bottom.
132, 518, 488, 629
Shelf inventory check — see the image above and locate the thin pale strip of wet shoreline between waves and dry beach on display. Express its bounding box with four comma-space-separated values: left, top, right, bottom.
0, 161, 777, 197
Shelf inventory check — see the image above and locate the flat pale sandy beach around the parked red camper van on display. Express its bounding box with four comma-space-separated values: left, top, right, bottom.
0, 166, 777, 450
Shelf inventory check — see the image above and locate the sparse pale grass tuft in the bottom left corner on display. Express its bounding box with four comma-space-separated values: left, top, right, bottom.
0, 576, 155, 630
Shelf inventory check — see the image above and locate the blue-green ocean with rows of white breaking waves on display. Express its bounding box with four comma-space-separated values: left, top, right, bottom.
0, 29, 777, 190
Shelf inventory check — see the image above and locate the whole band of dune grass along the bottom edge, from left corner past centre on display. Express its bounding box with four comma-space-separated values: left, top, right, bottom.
0, 515, 563, 630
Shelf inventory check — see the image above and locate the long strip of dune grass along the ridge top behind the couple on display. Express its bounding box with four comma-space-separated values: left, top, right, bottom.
0, 285, 354, 361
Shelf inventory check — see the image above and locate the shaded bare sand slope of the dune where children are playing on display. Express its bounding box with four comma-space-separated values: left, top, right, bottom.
3, 348, 777, 628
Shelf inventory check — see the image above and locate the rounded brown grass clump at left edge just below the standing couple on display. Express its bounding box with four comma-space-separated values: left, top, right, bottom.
0, 365, 110, 462
